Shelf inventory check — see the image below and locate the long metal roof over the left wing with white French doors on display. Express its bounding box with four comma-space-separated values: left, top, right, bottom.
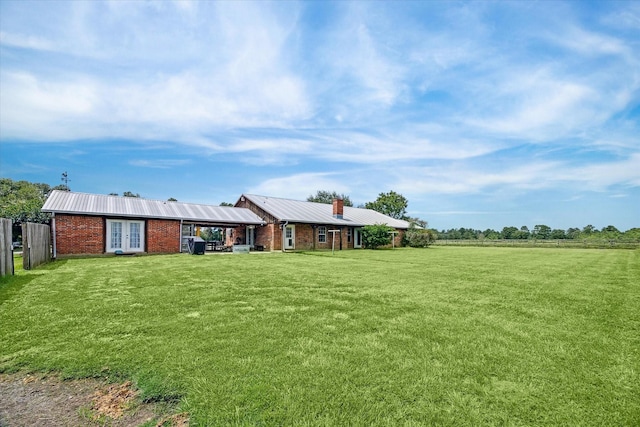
42, 190, 264, 225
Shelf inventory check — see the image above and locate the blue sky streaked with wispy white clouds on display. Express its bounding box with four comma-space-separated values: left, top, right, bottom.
0, 0, 640, 230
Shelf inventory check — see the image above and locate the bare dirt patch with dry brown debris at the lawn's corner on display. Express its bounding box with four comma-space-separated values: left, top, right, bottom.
0, 374, 189, 427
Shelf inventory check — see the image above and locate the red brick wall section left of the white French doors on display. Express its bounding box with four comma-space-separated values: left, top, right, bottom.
55, 214, 105, 255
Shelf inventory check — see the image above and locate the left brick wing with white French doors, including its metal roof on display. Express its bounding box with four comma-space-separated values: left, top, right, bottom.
42, 190, 264, 258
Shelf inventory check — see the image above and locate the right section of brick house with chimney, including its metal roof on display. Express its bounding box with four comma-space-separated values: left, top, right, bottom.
232, 194, 410, 251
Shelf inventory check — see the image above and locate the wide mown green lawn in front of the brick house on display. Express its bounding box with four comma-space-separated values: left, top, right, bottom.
0, 247, 640, 426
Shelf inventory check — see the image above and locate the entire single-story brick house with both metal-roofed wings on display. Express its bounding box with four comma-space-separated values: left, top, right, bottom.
42, 190, 409, 258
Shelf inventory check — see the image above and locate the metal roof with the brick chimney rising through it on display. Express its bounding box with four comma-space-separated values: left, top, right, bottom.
241, 194, 409, 229
